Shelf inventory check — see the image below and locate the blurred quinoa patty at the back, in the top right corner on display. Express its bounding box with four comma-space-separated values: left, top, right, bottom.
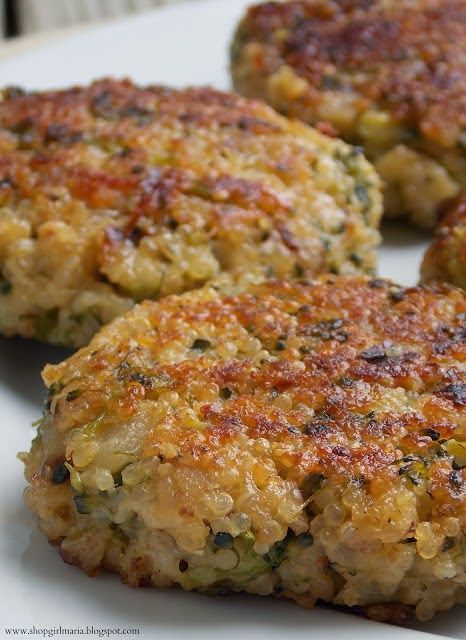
232, 0, 466, 228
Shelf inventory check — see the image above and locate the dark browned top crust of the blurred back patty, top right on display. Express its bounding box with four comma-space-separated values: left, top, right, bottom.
233, 0, 466, 148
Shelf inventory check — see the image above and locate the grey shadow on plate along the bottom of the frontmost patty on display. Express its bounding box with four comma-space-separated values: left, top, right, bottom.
11, 530, 463, 639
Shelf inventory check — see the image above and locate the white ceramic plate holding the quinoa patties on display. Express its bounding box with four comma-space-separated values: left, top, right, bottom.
0, 0, 456, 640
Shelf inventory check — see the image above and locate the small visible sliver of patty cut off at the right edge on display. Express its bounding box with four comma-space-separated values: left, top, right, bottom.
421, 196, 466, 289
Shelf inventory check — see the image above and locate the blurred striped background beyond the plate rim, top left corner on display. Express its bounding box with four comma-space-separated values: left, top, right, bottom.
0, 0, 193, 40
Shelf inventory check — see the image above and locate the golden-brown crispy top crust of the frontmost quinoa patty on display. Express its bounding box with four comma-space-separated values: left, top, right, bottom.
45, 277, 466, 496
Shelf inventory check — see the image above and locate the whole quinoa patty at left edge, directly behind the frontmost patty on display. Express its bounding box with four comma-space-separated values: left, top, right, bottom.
0, 80, 381, 346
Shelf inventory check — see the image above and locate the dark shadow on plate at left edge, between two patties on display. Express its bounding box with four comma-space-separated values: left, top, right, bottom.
0, 338, 71, 406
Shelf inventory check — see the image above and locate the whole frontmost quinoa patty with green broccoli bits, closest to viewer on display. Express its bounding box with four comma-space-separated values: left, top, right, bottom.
23, 276, 466, 623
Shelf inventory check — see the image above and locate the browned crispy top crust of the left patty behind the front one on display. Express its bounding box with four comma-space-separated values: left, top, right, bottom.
0, 80, 302, 221
